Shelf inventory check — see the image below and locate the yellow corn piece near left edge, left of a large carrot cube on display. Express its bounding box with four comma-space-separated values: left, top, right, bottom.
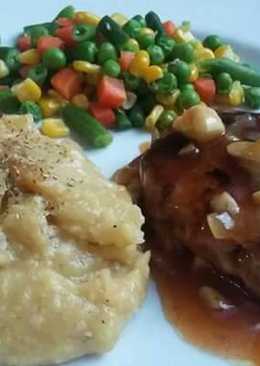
11, 78, 42, 102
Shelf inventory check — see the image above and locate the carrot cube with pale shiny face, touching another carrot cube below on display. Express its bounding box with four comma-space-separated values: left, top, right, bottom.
97, 76, 126, 108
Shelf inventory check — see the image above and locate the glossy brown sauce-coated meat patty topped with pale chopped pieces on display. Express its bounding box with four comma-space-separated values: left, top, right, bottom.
118, 104, 260, 296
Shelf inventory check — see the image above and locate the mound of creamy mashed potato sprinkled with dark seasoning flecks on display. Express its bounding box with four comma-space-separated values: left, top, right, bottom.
0, 116, 149, 366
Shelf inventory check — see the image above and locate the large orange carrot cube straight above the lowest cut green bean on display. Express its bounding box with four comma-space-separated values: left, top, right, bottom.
51, 67, 82, 99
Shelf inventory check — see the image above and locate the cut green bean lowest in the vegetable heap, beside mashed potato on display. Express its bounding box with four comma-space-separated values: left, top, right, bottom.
62, 104, 113, 148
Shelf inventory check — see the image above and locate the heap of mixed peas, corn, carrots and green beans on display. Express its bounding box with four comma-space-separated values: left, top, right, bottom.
0, 6, 260, 148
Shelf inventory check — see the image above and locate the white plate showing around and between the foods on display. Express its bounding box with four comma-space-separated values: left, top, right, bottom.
0, 0, 260, 366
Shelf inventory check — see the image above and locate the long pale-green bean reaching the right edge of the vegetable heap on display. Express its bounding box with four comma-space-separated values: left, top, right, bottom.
200, 58, 260, 87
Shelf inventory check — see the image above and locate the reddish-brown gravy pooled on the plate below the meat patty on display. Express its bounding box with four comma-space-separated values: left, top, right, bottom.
152, 247, 260, 366
